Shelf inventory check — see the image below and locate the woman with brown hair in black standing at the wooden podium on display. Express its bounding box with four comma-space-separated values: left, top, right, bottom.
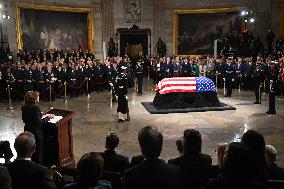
21, 91, 54, 164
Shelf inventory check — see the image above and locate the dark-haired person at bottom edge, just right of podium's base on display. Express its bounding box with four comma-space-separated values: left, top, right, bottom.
64, 152, 112, 189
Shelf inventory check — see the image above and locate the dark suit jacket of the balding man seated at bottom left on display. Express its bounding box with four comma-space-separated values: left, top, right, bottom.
5, 159, 56, 189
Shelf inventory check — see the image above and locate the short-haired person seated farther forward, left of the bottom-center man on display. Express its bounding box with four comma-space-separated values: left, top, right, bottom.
100, 133, 130, 174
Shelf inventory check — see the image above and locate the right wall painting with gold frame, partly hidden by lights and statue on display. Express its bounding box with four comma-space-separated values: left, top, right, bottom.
173, 7, 242, 55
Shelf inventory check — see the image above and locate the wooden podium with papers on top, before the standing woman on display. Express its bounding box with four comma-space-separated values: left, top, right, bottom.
43, 109, 75, 167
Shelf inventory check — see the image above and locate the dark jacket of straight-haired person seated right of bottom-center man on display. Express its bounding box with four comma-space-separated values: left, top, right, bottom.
170, 154, 212, 189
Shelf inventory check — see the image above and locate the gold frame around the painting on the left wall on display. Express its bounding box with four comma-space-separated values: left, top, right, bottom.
16, 3, 95, 53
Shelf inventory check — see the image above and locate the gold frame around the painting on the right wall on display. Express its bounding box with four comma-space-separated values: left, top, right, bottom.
173, 7, 244, 56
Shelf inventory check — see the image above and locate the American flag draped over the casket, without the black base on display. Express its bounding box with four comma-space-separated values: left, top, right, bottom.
155, 77, 217, 94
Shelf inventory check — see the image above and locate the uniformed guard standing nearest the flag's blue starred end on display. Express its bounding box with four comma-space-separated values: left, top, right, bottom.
223, 57, 236, 97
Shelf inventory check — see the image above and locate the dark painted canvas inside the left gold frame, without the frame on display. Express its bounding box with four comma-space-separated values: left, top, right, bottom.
20, 9, 88, 50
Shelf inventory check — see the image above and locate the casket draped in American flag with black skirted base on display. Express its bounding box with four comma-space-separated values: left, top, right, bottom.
153, 77, 219, 109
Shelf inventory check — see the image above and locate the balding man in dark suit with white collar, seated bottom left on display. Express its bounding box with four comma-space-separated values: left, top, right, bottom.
5, 132, 56, 189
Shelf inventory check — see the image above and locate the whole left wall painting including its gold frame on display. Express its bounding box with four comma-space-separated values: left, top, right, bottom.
16, 3, 94, 51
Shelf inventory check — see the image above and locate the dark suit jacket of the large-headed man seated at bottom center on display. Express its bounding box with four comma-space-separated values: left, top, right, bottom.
124, 159, 182, 189
